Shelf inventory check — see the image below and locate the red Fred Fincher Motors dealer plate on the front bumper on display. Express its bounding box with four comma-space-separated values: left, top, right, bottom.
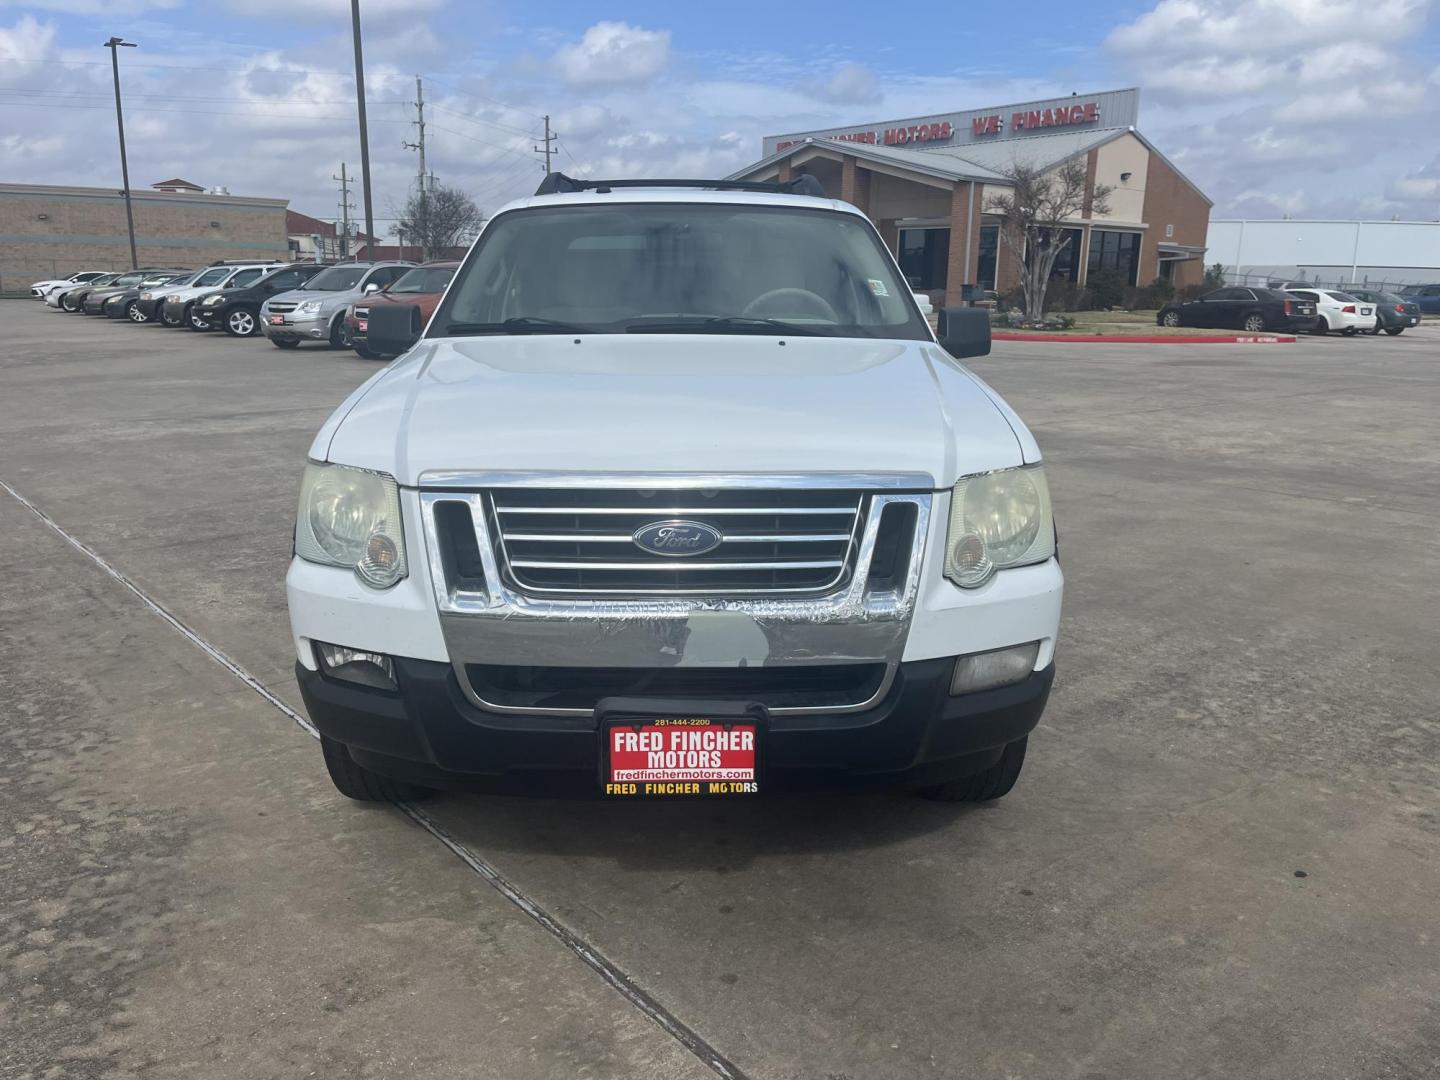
602, 717, 760, 796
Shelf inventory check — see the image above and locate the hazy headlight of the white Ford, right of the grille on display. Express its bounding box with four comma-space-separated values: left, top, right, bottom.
945, 465, 1056, 589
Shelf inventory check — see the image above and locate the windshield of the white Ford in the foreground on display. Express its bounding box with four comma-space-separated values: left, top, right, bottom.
429, 203, 930, 340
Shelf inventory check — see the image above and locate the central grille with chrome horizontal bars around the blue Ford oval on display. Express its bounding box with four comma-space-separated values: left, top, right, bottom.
482, 488, 867, 596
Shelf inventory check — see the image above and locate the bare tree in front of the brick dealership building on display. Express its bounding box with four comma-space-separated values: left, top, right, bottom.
985, 157, 1115, 323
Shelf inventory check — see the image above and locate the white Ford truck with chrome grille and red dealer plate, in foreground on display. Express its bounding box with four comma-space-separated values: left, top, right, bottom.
287, 174, 1063, 801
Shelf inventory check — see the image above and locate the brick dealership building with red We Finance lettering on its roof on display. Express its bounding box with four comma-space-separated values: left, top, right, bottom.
730, 89, 1211, 304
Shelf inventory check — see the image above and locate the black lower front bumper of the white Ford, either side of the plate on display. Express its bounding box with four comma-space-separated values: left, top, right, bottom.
295, 657, 1054, 795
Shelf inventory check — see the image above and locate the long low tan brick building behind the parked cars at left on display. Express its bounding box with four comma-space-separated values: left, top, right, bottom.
0, 180, 291, 294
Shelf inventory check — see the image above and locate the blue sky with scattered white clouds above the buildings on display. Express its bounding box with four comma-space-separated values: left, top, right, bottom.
0, 0, 1440, 232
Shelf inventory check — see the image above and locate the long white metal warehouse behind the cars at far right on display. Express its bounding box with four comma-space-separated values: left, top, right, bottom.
1205, 219, 1440, 285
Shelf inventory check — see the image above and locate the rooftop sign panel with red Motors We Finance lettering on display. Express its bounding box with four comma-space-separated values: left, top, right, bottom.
765, 89, 1139, 157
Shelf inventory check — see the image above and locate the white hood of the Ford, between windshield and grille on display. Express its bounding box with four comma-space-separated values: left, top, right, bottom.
319, 334, 1038, 487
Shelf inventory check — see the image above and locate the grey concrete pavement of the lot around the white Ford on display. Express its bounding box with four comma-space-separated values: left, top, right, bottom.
0, 301, 1440, 1080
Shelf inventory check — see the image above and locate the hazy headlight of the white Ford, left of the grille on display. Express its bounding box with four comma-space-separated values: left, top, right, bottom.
295, 465, 406, 589
